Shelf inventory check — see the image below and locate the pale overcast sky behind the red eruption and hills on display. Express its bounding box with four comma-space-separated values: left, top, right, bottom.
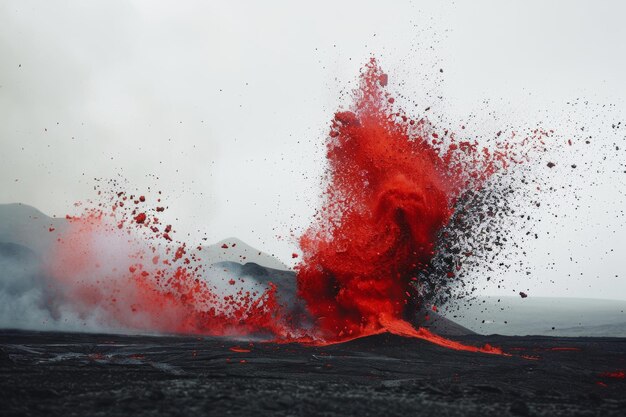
0, 0, 626, 299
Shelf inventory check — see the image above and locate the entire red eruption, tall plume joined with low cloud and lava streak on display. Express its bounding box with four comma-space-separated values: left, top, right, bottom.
42, 59, 545, 353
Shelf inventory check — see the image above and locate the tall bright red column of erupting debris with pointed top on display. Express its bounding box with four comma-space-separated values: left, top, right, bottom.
297, 59, 542, 340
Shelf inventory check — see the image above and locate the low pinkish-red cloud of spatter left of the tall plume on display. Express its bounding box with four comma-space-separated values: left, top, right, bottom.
46, 192, 290, 338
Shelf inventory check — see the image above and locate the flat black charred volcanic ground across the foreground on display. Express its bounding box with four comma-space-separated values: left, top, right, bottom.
0, 330, 626, 416
